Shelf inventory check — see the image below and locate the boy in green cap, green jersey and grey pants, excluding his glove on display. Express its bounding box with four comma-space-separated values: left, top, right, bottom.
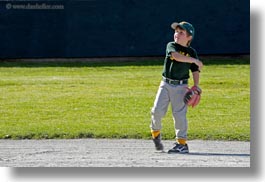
150, 21, 203, 153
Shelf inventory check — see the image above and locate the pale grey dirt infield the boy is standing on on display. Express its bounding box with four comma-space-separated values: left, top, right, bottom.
0, 139, 250, 167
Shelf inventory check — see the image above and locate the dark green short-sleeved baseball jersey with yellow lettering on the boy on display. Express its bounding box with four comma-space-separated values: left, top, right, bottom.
162, 42, 199, 80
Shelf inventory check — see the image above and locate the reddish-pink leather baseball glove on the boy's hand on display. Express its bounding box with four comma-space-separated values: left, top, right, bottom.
184, 86, 202, 107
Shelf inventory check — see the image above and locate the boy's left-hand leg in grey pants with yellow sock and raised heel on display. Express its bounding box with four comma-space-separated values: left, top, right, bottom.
150, 81, 169, 150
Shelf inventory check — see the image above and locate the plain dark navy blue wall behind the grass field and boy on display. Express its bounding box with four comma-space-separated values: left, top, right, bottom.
0, 0, 250, 58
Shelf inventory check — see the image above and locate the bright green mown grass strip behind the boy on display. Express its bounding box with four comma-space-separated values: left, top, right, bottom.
0, 58, 250, 141
